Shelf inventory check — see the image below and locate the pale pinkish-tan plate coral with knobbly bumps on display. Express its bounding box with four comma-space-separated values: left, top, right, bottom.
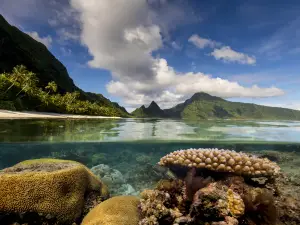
159, 148, 280, 176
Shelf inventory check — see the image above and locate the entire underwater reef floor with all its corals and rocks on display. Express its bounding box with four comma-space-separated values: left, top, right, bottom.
0, 149, 300, 225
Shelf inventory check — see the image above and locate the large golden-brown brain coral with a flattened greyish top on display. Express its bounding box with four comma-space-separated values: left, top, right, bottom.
0, 159, 107, 223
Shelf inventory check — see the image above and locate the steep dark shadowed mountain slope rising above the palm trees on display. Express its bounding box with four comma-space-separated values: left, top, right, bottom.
0, 15, 78, 93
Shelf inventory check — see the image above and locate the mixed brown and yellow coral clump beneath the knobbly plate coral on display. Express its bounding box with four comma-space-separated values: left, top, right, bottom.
139, 171, 278, 225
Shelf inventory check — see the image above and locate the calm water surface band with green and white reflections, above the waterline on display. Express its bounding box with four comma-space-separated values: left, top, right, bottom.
0, 119, 300, 142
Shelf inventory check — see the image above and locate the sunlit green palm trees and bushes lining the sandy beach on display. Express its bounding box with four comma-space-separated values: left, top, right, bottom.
0, 66, 126, 116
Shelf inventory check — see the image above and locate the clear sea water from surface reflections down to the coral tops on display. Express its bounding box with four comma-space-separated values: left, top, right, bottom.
0, 119, 300, 195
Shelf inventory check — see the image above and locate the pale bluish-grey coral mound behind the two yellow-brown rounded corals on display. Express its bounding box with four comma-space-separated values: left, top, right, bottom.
91, 164, 139, 196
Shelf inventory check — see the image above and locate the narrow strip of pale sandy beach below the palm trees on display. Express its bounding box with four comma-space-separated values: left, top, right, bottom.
0, 109, 121, 119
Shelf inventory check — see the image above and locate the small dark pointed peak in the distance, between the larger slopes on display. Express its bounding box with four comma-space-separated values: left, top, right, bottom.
131, 101, 166, 118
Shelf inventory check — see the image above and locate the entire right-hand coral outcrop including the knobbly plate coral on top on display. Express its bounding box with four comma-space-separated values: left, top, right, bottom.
139, 149, 300, 225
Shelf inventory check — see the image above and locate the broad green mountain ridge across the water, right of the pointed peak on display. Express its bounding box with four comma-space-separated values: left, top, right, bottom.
134, 92, 300, 120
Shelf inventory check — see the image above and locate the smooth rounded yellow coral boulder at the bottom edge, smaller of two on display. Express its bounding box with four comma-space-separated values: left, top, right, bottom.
81, 196, 140, 225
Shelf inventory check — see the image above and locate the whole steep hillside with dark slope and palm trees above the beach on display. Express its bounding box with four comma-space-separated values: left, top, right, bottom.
0, 15, 129, 117
